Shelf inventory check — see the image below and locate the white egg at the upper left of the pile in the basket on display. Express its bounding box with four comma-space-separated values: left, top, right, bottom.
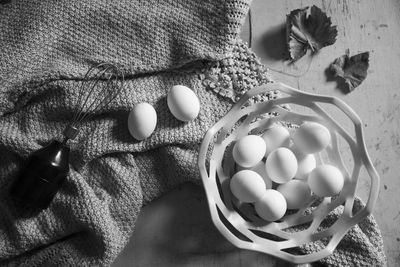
232, 135, 265, 168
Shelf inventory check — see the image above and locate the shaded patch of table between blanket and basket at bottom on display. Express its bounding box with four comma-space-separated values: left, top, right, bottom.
113, 184, 290, 267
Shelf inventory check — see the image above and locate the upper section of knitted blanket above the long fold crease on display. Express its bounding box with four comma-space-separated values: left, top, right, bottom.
0, 0, 249, 113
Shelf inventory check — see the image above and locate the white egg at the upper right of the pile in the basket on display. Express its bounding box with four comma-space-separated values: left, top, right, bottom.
293, 122, 331, 154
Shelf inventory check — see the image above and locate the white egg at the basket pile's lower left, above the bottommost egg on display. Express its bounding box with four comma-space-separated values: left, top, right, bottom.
230, 170, 266, 203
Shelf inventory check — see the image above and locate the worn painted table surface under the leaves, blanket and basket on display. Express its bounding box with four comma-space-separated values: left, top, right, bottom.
114, 0, 400, 266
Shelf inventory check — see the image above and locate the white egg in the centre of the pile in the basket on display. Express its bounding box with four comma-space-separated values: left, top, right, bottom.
265, 147, 297, 184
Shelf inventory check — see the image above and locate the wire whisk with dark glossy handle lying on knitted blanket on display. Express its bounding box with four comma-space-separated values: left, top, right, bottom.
10, 63, 124, 210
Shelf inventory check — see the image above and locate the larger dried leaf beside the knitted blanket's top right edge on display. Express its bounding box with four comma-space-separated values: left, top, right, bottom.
286, 6, 337, 60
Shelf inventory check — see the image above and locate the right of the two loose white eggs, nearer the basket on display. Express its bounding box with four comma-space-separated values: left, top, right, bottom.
167, 85, 200, 122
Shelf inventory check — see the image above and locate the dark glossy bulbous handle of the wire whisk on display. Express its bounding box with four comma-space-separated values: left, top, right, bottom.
10, 140, 70, 210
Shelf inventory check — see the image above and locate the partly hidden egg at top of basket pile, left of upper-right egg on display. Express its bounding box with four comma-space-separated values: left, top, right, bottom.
262, 125, 290, 157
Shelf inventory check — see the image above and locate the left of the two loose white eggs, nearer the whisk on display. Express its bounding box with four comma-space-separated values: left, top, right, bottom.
128, 103, 157, 141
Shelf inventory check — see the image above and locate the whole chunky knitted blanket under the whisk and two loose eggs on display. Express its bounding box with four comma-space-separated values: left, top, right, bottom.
0, 0, 385, 266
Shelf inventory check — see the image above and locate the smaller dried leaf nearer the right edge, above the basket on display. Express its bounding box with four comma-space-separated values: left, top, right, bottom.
329, 49, 369, 92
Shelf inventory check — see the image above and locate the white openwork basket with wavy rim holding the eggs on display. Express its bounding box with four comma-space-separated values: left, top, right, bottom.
198, 83, 379, 264
